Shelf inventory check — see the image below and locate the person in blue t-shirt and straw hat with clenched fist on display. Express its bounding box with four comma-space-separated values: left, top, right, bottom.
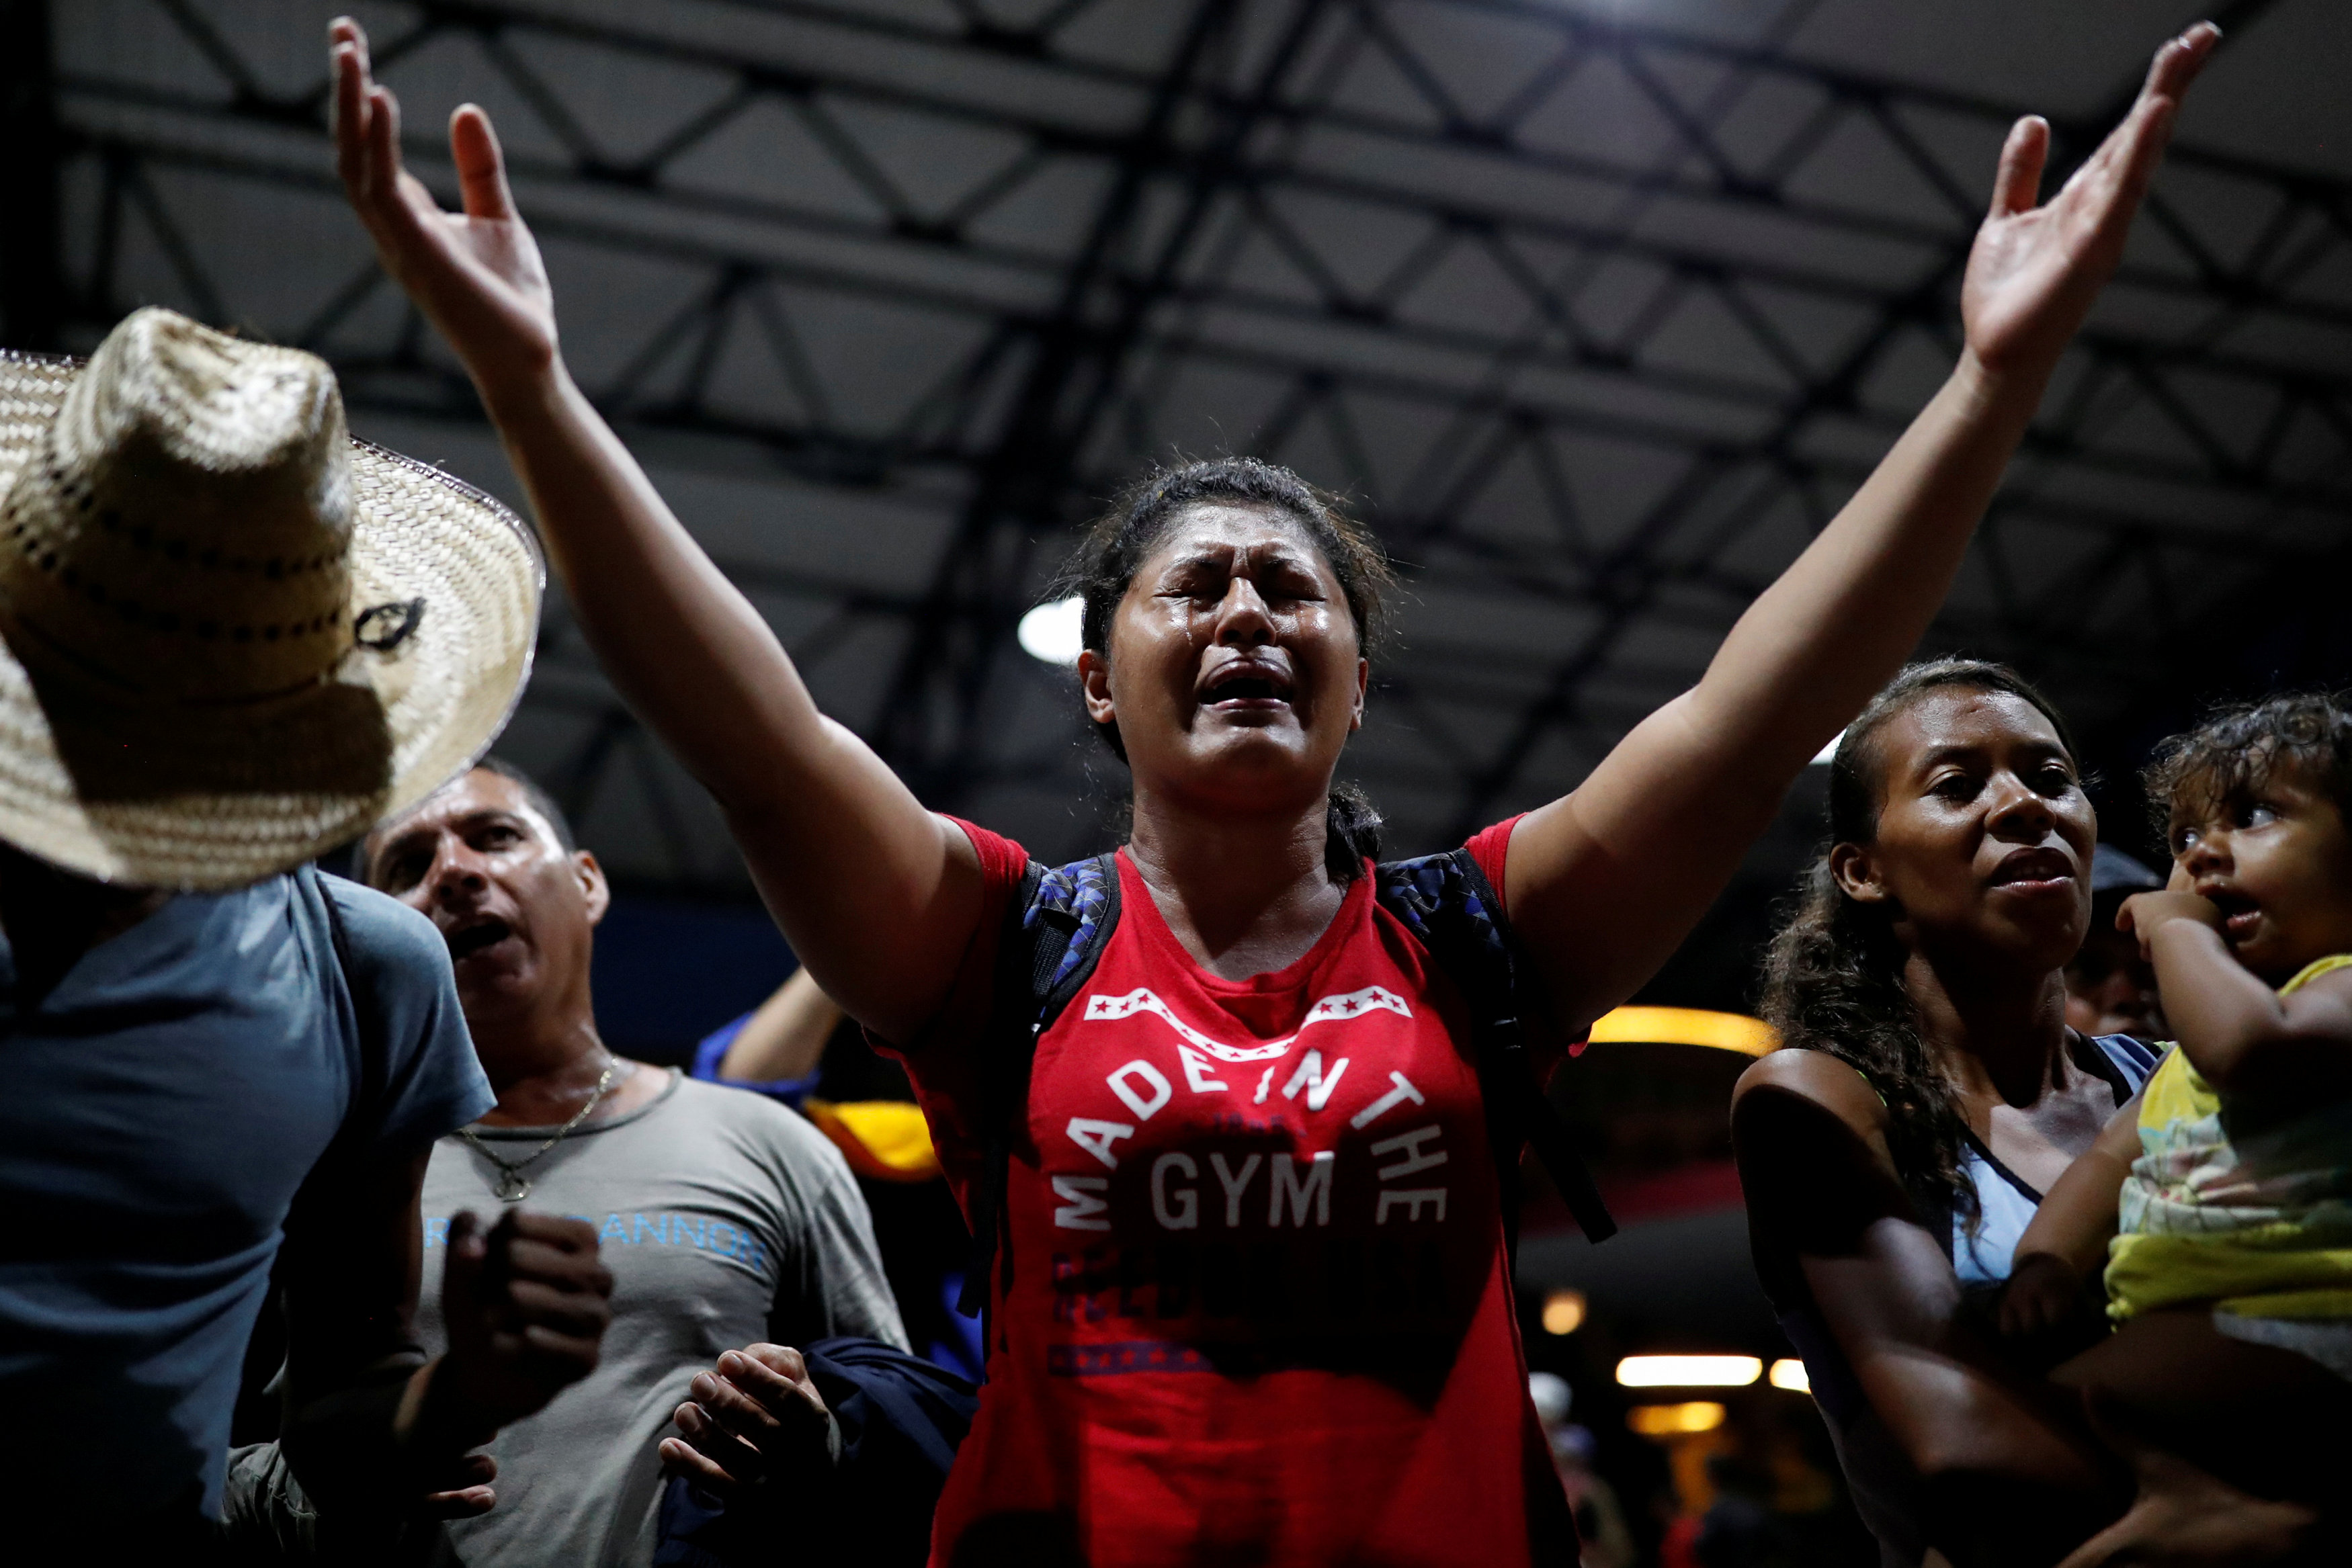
0, 310, 610, 1563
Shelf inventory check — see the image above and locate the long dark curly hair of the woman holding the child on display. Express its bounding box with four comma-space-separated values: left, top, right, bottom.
1764, 658, 2074, 1229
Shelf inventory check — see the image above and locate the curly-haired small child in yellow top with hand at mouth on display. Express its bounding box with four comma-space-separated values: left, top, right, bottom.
1999, 696, 2352, 1485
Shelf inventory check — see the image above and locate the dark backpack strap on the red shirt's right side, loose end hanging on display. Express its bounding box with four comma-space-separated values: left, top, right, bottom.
1374, 848, 1616, 1253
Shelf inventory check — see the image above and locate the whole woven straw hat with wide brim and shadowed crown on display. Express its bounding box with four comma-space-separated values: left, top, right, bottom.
0, 308, 546, 891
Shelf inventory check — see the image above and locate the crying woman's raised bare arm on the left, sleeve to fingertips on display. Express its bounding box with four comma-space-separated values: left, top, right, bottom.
329, 16, 981, 1039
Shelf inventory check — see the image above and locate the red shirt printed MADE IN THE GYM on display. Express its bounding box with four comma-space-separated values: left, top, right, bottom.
903, 823, 1574, 1568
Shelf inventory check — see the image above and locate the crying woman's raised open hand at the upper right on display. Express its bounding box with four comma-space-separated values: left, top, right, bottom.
1960, 21, 2220, 376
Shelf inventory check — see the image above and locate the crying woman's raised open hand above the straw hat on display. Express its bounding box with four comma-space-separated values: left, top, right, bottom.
327, 16, 558, 395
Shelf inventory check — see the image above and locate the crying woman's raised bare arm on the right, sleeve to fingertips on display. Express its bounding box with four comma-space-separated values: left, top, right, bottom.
1505, 24, 2220, 1025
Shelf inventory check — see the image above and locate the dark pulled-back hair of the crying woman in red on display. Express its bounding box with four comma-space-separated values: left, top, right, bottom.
1054, 458, 1397, 881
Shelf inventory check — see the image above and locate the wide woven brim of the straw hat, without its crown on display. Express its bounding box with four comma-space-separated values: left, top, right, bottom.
0, 350, 546, 891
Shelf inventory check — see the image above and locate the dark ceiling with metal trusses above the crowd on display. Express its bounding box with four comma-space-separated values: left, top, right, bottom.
5, 0, 2352, 891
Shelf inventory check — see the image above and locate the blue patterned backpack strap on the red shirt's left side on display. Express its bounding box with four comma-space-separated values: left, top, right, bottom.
955, 856, 1120, 1345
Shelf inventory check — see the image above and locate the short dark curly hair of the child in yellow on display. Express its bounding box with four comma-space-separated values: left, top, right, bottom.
2140, 691, 2352, 844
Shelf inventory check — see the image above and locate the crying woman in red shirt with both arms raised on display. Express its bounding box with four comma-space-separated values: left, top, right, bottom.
332, 21, 2216, 1568
